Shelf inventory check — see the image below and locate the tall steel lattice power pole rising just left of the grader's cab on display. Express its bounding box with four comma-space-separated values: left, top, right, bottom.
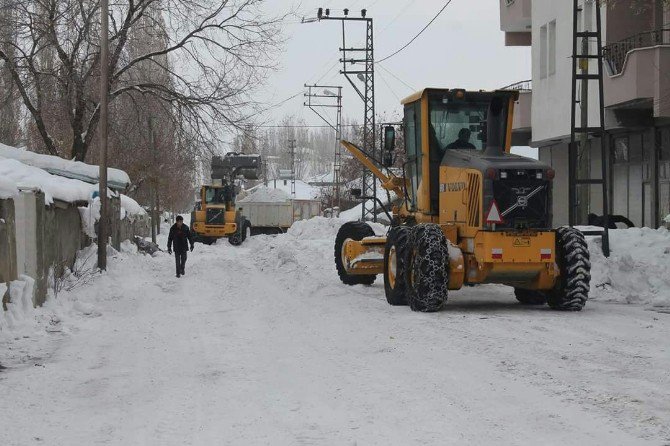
303, 8, 378, 221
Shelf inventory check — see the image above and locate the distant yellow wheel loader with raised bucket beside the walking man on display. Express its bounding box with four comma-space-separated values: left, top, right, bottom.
191, 153, 261, 246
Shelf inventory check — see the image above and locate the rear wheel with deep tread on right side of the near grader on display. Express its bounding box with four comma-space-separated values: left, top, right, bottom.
547, 226, 591, 311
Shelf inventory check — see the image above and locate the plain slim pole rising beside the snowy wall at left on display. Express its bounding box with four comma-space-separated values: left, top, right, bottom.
98, 0, 109, 271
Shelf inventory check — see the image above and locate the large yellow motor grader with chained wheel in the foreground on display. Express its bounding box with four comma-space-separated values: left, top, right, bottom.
335, 89, 590, 311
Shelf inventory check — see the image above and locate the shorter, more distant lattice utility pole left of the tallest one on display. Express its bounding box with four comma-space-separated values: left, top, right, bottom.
304, 85, 342, 217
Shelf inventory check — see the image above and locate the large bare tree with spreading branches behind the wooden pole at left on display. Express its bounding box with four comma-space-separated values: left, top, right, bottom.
0, 0, 283, 161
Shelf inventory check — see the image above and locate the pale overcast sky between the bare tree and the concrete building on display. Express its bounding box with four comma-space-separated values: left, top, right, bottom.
260, 0, 531, 128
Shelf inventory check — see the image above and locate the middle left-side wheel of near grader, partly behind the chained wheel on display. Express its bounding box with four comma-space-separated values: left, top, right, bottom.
384, 226, 410, 305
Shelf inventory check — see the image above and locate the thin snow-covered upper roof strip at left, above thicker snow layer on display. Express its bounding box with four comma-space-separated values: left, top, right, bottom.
0, 144, 130, 190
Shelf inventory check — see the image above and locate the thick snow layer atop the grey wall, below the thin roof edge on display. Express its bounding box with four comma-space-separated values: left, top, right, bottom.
0, 158, 98, 205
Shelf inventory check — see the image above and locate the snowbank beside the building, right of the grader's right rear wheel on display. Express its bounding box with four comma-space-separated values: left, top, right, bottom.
589, 228, 670, 307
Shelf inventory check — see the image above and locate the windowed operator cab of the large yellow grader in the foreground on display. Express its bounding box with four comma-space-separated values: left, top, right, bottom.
403, 89, 516, 218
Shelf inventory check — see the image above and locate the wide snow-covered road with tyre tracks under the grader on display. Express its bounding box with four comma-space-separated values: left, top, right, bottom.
0, 220, 670, 445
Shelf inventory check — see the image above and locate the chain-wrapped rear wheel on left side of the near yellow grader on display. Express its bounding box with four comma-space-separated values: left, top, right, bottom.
405, 224, 449, 313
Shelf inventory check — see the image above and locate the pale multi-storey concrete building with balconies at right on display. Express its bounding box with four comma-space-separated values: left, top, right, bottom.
500, 0, 670, 227
